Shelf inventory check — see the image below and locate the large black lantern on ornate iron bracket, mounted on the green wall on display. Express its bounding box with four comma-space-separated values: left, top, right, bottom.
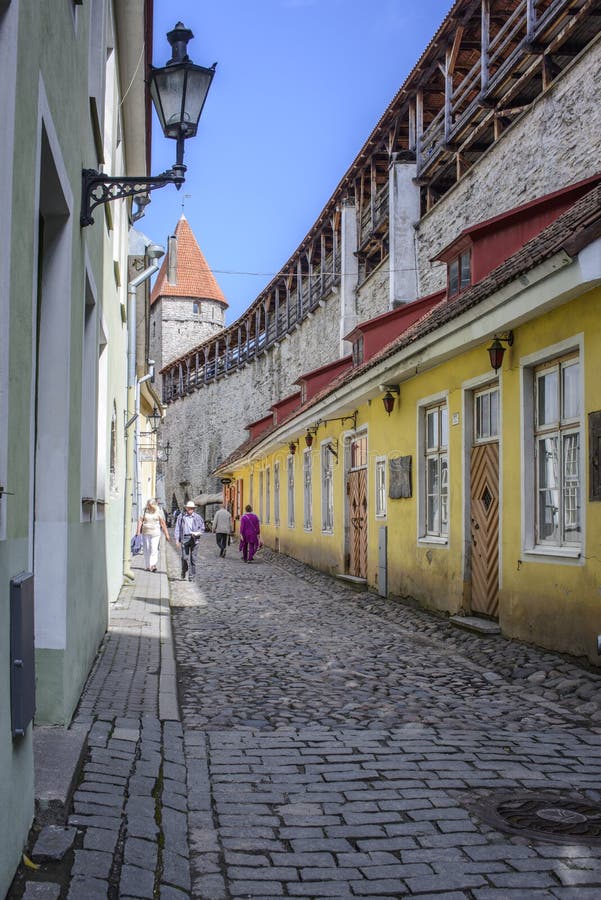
80, 22, 217, 228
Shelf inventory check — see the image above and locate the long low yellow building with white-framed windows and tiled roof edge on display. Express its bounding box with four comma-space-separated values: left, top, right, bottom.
218, 189, 601, 663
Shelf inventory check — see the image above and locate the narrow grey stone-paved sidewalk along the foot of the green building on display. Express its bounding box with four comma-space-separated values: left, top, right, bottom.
8, 557, 185, 900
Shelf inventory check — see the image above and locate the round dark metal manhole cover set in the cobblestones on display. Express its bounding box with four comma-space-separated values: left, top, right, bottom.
475, 793, 601, 844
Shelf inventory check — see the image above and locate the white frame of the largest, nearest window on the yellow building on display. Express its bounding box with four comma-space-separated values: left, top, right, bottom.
520, 334, 587, 565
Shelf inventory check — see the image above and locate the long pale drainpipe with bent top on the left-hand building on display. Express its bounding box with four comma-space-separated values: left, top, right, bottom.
123, 244, 165, 581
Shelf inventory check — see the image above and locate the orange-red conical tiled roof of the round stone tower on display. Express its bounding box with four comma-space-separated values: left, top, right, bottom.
150, 213, 228, 307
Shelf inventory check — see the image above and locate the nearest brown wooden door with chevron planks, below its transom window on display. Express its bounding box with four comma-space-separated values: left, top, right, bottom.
471, 443, 499, 616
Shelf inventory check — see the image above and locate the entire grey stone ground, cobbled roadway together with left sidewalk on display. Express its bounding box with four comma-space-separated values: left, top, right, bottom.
9, 535, 601, 900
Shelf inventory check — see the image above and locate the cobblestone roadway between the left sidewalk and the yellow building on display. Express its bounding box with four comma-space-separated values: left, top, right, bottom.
169, 535, 601, 900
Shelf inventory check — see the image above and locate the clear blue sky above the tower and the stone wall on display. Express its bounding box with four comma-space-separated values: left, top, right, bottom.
144, 0, 451, 324
